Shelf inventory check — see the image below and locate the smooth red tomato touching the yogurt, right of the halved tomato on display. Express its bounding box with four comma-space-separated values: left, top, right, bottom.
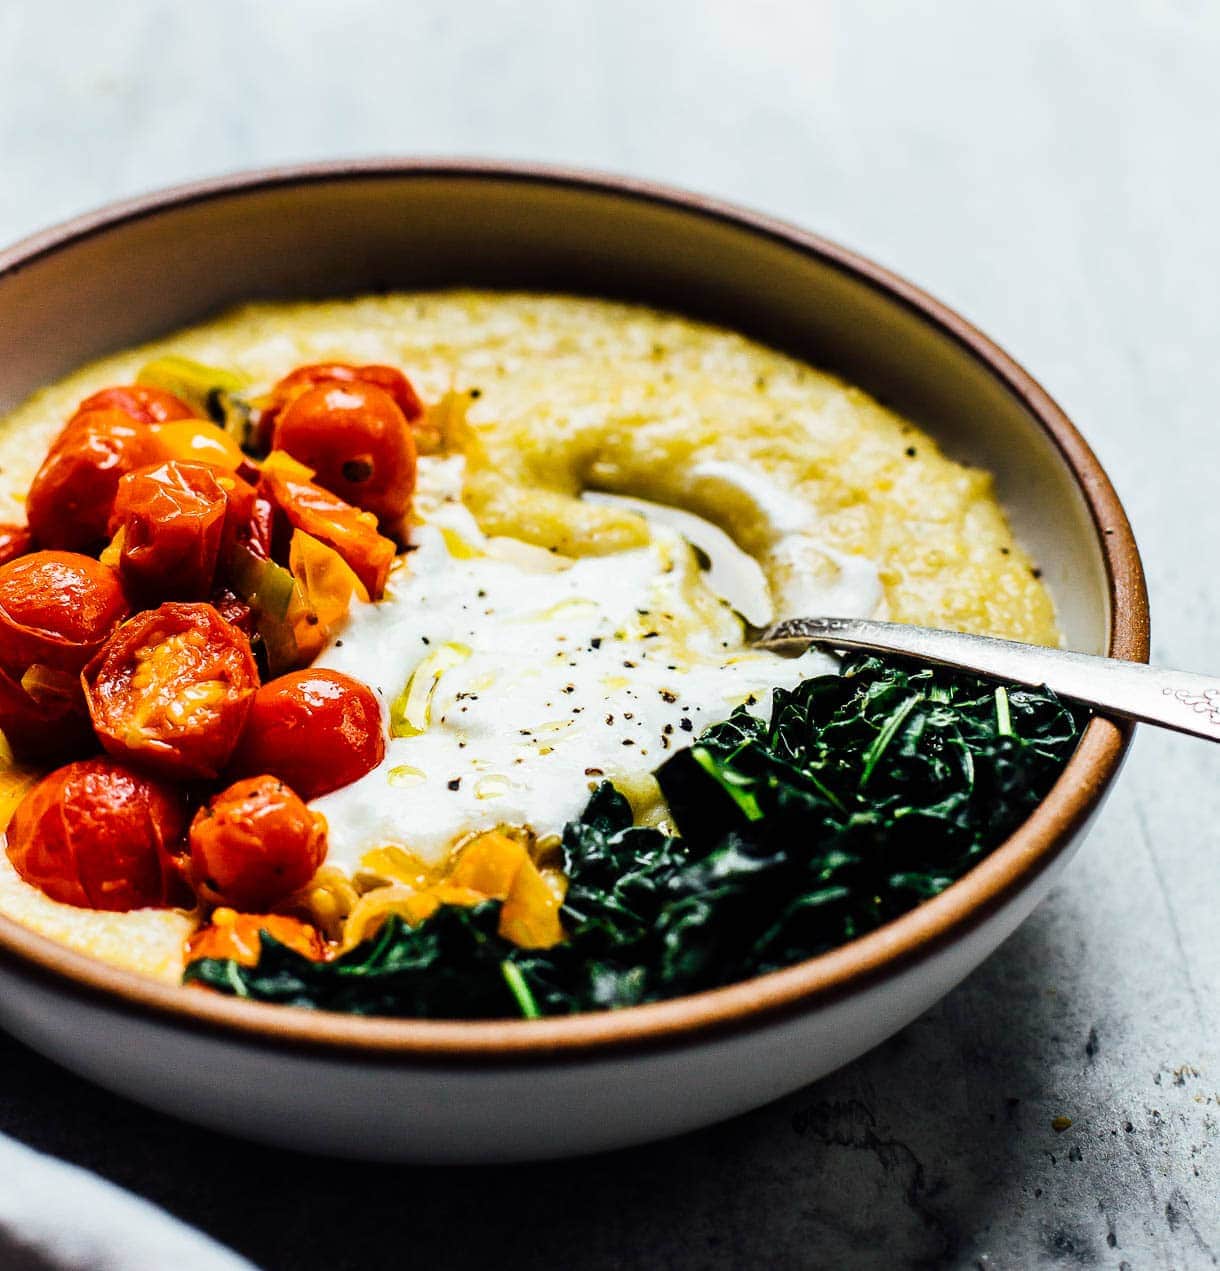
230, 667, 385, 799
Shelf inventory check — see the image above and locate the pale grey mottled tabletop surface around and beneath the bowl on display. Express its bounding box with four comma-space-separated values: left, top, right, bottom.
0, 0, 1220, 1271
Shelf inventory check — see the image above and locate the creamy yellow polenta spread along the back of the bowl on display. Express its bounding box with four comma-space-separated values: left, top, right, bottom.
0, 292, 1057, 979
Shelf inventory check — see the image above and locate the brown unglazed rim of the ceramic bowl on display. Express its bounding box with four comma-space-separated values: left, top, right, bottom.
0, 158, 1149, 1068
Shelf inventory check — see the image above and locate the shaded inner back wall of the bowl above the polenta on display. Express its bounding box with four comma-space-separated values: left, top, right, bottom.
0, 168, 1112, 652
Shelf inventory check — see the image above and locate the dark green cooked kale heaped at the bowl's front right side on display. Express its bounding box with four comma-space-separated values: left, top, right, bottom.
186, 657, 1087, 1018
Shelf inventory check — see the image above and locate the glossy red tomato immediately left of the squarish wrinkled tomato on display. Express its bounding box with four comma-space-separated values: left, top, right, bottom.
25, 411, 160, 550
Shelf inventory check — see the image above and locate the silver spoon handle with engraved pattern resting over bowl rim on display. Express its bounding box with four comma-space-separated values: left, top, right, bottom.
755, 618, 1220, 741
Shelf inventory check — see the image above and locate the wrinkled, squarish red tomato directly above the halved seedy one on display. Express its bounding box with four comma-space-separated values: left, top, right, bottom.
111, 459, 228, 600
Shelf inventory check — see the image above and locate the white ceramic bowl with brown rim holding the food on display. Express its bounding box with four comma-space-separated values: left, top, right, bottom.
0, 161, 1148, 1162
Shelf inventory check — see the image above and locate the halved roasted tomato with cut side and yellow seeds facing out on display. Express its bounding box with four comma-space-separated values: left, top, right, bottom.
81, 602, 258, 778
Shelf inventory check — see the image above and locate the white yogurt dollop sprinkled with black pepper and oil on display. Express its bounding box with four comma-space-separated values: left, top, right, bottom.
314, 459, 876, 871
